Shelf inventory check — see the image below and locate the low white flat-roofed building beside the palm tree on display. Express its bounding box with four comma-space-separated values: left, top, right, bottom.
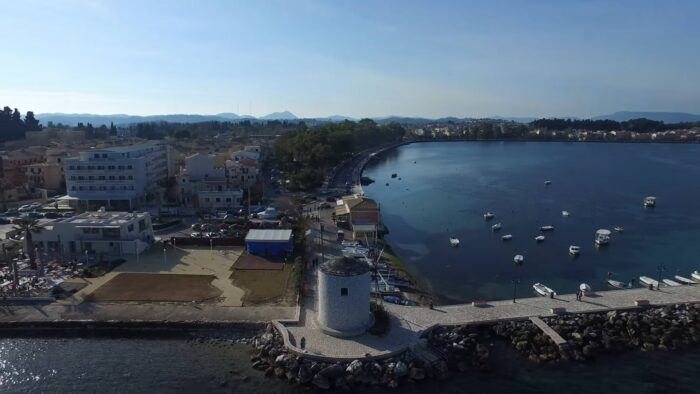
32, 210, 154, 256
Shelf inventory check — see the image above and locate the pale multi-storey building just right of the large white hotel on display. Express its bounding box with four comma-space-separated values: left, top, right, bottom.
177, 153, 243, 210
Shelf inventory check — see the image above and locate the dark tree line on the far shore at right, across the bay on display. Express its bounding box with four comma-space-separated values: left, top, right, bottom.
530, 118, 700, 133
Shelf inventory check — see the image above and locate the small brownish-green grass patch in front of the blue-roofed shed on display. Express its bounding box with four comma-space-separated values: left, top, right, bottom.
230, 264, 293, 305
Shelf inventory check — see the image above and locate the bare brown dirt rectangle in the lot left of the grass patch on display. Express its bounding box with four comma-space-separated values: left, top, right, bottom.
85, 273, 222, 302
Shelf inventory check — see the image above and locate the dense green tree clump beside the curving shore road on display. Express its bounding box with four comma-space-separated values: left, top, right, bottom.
274, 119, 405, 190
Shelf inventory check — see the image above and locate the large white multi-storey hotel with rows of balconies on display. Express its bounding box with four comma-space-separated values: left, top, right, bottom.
64, 142, 168, 210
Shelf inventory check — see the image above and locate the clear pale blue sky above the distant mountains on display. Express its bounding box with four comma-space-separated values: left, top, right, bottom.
0, 0, 700, 117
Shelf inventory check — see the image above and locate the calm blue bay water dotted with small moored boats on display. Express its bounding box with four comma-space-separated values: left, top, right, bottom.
364, 142, 700, 303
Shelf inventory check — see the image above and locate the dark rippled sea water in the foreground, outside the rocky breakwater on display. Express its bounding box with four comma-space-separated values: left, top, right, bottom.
0, 338, 700, 394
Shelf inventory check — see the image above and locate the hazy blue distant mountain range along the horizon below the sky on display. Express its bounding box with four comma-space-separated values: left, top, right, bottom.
36, 111, 700, 126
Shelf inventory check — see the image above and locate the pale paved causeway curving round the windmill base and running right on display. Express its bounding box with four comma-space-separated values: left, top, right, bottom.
278, 285, 700, 360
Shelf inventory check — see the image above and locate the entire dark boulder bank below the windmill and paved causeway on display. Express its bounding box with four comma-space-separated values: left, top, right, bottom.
252, 304, 700, 390
